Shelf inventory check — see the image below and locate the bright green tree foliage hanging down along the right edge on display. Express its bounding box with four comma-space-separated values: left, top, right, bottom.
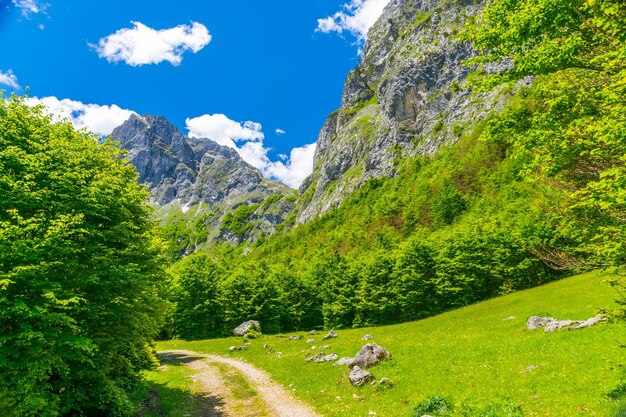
464, 0, 626, 269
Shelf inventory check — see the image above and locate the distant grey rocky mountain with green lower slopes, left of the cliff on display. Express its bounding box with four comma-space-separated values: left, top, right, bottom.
111, 115, 294, 252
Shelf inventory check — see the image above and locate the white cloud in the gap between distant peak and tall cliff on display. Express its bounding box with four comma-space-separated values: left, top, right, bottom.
185, 114, 315, 188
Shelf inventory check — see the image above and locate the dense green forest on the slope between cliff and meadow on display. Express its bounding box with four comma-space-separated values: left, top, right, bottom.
165, 124, 561, 338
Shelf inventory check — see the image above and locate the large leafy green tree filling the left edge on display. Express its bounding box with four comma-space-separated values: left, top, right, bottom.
0, 96, 165, 417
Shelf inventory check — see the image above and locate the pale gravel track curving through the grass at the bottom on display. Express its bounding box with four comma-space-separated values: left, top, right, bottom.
161, 350, 321, 417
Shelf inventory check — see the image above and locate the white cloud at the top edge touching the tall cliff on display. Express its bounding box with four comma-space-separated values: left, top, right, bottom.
317, 0, 390, 41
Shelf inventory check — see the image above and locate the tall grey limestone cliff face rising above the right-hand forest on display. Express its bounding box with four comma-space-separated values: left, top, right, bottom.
297, 0, 503, 223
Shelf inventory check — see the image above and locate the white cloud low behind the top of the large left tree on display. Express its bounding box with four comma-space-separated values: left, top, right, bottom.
26, 97, 136, 136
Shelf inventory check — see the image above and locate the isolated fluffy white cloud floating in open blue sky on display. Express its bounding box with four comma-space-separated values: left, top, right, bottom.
90, 22, 212, 67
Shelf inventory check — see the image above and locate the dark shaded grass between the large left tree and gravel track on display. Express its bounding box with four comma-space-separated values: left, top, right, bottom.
136, 354, 226, 417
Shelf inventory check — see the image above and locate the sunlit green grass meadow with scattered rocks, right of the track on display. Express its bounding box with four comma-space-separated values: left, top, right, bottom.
158, 274, 626, 417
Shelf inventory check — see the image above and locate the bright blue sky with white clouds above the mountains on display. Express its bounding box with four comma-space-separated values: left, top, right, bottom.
0, 0, 389, 187
